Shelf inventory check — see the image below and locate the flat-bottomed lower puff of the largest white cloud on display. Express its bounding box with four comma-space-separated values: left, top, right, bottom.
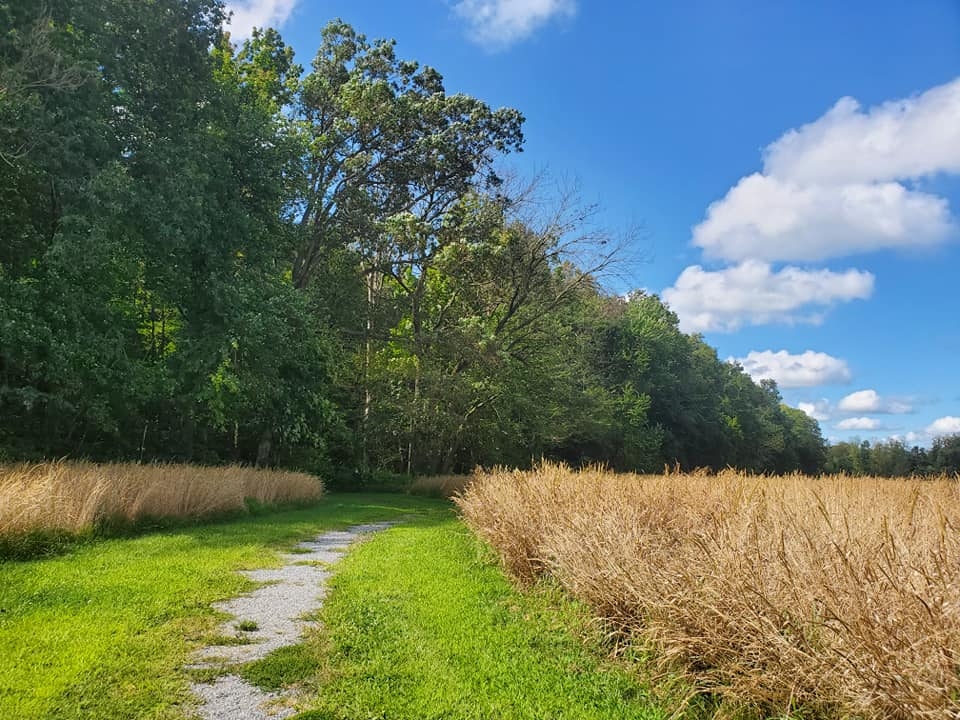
693, 174, 960, 260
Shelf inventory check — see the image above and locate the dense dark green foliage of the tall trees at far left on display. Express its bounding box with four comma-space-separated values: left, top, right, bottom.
0, 0, 342, 466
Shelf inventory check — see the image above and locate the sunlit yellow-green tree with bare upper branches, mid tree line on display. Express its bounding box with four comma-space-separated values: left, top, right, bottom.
360, 186, 616, 471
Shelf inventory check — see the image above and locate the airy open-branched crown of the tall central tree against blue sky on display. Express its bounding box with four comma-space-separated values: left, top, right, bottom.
293, 21, 523, 287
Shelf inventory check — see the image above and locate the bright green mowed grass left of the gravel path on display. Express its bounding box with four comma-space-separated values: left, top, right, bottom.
0, 495, 449, 720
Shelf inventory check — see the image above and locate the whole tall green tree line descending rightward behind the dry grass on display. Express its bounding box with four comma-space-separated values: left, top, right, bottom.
9, 0, 928, 484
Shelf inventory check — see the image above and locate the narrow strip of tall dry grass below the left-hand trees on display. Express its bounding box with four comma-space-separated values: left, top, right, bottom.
0, 461, 323, 535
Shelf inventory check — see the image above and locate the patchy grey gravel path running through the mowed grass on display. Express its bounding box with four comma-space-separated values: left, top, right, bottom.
189, 522, 394, 720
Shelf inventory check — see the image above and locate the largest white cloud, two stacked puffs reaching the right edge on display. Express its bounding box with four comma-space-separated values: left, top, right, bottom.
693, 78, 960, 262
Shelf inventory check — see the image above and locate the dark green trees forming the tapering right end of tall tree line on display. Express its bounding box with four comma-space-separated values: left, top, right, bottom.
565, 293, 824, 472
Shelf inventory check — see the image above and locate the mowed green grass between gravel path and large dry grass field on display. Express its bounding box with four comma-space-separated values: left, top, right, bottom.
286, 515, 665, 720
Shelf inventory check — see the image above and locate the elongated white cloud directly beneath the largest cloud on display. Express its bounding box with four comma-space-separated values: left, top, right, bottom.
663, 260, 874, 332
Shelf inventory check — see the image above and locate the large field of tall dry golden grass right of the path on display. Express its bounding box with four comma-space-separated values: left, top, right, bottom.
457, 465, 960, 718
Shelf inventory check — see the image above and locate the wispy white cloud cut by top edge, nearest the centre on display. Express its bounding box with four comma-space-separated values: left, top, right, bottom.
453, 0, 577, 48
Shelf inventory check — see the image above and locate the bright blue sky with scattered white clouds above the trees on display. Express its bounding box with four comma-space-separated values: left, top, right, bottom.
228, 0, 960, 445
